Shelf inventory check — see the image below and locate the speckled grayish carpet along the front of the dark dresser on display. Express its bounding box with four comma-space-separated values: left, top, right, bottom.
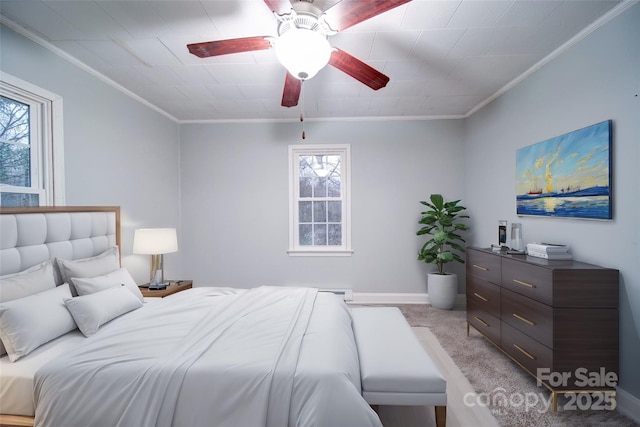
398, 304, 640, 427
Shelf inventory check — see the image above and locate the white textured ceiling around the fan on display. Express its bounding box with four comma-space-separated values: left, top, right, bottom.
0, 0, 625, 122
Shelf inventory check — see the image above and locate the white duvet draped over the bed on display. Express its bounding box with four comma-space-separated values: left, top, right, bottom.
34, 287, 381, 427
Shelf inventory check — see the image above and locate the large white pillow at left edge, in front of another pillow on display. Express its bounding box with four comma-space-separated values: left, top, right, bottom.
0, 283, 76, 362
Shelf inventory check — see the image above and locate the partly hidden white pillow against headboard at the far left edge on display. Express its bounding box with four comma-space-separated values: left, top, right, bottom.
0, 260, 56, 356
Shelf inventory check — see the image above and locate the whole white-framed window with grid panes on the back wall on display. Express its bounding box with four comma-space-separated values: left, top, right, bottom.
289, 145, 353, 256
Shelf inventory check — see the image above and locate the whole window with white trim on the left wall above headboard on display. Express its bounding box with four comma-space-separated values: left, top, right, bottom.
0, 73, 64, 206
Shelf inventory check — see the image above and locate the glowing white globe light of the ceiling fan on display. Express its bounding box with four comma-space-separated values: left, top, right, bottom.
275, 28, 332, 80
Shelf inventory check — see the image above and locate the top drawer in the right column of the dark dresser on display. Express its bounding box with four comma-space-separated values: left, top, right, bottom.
501, 258, 553, 305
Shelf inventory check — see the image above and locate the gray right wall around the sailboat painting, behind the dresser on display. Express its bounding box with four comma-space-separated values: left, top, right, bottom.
464, 4, 640, 397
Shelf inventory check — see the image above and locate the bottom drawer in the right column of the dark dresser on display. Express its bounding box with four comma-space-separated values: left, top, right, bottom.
502, 321, 553, 375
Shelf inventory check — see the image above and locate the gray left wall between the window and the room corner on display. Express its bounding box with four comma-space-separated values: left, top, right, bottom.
0, 26, 180, 283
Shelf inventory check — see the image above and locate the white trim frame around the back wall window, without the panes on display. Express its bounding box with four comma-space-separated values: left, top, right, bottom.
287, 144, 353, 256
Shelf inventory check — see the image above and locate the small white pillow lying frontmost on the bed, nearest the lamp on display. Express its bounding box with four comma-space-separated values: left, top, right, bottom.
64, 286, 142, 337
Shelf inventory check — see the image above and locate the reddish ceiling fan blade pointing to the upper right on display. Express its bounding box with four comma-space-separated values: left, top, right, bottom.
322, 0, 411, 31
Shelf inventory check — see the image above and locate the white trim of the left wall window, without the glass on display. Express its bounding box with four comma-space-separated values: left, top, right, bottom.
0, 72, 65, 206
